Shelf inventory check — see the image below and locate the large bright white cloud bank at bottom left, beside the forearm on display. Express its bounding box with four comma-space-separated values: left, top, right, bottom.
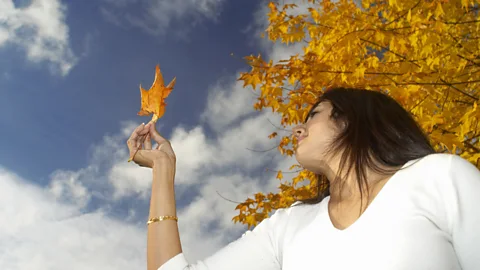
0, 168, 145, 270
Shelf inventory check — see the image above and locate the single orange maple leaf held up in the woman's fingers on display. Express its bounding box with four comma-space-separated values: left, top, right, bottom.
137, 65, 176, 123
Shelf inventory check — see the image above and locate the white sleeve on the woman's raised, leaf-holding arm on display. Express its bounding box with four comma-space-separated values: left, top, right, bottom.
158, 206, 287, 270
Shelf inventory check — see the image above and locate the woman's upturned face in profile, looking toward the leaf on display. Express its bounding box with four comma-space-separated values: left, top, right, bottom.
293, 101, 340, 173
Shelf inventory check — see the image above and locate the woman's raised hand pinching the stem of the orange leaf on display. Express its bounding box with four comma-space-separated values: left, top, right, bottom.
127, 122, 176, 169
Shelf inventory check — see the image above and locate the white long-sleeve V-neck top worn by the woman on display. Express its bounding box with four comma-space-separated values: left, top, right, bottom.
159, 154, 480, 270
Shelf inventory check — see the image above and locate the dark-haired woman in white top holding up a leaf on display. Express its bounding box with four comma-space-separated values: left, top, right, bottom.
128, 88, 480, 270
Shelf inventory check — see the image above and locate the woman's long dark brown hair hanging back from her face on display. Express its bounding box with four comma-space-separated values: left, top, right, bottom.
300, 88, 435, 208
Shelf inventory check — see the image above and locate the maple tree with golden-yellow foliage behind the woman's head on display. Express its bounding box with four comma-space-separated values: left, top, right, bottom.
233, 0, 480, 228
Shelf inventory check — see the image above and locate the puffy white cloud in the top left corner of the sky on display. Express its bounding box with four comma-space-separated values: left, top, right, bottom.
0, 0, 77, 75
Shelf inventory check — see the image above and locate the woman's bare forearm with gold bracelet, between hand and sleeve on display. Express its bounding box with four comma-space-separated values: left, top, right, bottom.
147, 162, 182, 270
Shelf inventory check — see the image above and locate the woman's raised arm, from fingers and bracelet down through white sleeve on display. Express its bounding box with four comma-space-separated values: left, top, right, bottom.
127, 124, 287, 270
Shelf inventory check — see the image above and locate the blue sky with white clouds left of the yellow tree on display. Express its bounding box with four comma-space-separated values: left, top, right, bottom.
0, 0, 304, 270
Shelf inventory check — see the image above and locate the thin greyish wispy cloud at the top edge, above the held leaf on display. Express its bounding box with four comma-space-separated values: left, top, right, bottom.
100, 0, 225, 38
